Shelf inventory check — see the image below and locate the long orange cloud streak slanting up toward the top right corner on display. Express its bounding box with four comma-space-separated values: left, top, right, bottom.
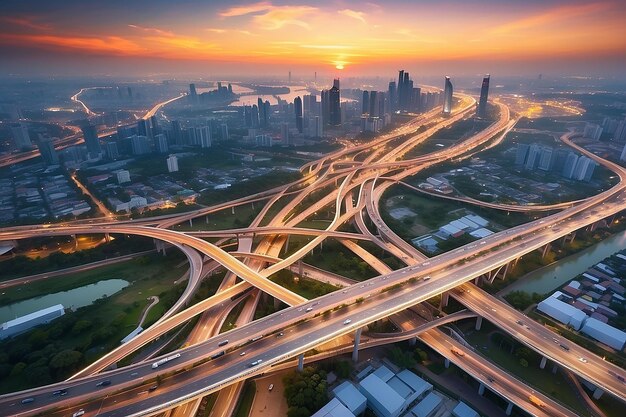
491, 2, 612, 34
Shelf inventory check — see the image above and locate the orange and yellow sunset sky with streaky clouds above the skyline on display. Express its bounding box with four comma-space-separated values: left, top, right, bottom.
0, 0, 626, 77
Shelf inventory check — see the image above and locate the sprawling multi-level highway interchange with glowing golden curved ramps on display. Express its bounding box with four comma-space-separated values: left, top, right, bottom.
0, 89, 626, 416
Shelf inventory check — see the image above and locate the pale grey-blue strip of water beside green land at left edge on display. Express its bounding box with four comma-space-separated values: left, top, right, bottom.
0, 279, 129, 323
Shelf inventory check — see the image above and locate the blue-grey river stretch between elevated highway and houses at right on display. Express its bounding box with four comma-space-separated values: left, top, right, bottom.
499, 230, 626, 295
